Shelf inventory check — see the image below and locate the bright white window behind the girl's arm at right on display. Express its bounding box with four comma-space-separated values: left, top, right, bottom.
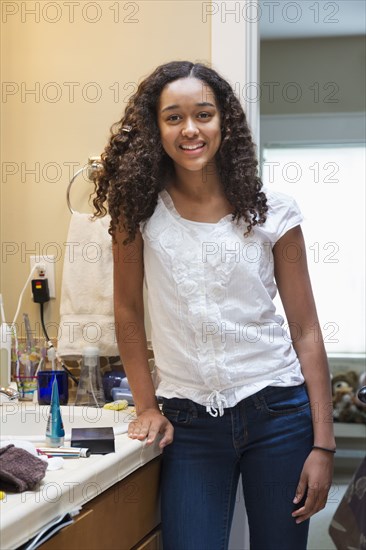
262, 144, 366, 354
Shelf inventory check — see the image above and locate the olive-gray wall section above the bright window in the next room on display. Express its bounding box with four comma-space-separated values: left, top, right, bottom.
260, 36, 366, 115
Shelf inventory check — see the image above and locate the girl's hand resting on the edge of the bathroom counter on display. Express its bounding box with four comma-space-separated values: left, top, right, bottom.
128, 408, 174, 449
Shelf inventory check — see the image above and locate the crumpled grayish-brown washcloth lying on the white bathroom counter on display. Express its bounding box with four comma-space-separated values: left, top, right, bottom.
0, 445, 47, 493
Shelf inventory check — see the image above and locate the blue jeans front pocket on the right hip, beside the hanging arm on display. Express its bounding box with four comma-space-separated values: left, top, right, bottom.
262, 384, 310, 416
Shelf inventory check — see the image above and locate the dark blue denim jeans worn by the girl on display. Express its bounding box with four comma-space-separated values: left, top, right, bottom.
161, 384, 313, 550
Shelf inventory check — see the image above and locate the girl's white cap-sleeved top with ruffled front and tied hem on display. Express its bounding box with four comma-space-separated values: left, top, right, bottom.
140, 190, 304, 416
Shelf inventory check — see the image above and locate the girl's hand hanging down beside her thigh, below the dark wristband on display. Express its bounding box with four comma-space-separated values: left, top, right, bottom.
292, 449, 334, 523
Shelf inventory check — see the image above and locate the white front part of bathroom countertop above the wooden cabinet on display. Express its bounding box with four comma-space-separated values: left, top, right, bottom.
0, 434, 161, 550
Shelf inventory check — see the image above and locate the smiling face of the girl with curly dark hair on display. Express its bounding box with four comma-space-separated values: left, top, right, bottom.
158, 78, 221, 171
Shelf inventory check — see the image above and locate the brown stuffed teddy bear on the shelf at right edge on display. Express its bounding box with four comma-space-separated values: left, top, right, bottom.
332, 371, 366, 424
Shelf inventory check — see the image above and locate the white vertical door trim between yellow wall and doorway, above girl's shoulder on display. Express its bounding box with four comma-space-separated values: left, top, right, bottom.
209, 0, 260, 148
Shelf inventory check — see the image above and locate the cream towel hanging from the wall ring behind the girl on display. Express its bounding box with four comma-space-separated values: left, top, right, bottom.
58, 212, 119, 357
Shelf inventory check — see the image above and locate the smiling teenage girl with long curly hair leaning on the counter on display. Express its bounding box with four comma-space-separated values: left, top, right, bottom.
94, 61, 335, 550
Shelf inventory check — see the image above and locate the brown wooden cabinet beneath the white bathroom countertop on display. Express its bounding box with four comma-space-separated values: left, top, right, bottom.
40, 457, 162, 550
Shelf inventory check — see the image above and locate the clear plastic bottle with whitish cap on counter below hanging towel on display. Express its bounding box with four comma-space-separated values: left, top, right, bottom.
75, 346, 106, 407
